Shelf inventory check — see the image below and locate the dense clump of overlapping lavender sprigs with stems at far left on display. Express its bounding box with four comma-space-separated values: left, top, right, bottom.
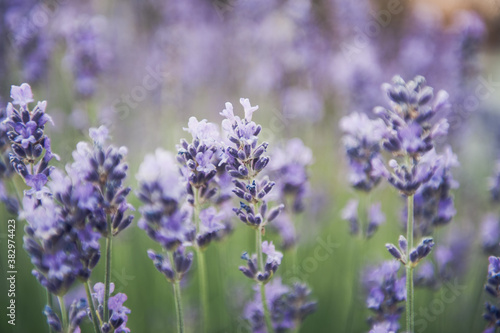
2, 84, 133, 332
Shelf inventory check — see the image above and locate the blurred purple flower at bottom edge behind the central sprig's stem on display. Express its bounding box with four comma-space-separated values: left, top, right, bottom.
244, 278, 316, 333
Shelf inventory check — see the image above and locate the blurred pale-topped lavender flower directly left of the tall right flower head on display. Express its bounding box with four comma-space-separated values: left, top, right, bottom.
340, 112, 386, 192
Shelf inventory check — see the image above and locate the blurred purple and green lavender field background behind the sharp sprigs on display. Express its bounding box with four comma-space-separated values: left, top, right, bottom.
0, 0, 500, 333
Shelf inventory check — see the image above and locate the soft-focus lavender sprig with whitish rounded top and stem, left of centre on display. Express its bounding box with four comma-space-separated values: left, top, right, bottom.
136, 149, 196, 332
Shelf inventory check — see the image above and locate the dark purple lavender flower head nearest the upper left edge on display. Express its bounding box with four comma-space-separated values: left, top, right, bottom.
4, 83, 58, 196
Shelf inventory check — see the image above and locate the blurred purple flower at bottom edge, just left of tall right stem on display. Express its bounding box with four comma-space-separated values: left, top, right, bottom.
364, 261, 406, 332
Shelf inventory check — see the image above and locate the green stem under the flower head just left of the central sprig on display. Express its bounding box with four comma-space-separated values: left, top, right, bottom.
193, 189, 210, 332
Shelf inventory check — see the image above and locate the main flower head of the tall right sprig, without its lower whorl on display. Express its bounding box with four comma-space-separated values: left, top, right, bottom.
374, 76, 449, 195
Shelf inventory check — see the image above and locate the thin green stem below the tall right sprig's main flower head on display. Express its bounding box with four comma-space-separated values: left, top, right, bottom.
406, 194, 414, 333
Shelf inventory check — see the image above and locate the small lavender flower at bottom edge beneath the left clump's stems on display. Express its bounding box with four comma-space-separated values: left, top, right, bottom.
92, 282, 130, 333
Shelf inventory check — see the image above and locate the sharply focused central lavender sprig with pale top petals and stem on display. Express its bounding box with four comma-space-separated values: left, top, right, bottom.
221, 98, 284, 331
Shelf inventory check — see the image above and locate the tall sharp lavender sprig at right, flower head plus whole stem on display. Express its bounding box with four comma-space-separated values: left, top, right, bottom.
374, 76, 449, 332
